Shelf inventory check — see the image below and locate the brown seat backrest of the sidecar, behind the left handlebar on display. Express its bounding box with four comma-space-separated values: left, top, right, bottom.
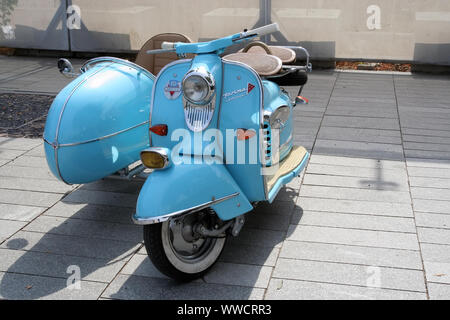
135, 33, 193, 75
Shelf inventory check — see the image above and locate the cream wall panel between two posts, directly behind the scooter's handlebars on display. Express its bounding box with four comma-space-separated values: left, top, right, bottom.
72, 0, 260, 50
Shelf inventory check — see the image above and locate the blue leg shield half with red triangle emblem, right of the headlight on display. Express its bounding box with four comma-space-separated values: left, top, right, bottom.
219, 61, 265, 202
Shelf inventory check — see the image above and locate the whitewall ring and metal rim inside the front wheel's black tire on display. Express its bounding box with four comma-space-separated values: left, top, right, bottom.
161, 214, 225, 273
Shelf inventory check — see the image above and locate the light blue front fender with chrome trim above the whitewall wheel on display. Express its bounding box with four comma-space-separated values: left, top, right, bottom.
133, 163, 253, 224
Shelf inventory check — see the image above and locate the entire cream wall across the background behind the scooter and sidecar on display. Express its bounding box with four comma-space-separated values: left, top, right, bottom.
0, 0, 450, 65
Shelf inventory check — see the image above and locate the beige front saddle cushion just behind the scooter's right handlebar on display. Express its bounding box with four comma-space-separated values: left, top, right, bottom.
223, 52, 283, 76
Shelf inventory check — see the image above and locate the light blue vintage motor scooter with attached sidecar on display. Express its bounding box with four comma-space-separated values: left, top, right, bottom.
44, 24, 311, 281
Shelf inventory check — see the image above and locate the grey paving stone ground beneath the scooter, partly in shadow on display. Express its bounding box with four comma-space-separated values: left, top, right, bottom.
0, 58, 450, 299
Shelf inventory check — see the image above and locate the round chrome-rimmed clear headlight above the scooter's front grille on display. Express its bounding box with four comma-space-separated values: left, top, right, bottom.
183, 69, 215, 104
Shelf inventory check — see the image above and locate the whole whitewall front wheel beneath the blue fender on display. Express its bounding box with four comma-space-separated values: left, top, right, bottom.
144, 210, 226, 281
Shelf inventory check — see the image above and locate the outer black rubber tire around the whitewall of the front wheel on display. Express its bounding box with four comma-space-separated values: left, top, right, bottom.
144, 223, 227, 282
